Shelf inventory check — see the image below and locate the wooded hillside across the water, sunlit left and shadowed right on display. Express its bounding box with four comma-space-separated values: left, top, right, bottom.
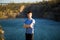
0, 1, 60, 21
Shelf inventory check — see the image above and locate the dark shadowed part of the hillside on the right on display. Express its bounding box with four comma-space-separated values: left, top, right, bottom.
20, 2, 60, 21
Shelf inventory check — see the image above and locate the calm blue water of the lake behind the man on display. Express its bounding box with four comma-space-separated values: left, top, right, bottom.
0, 18, 60, 40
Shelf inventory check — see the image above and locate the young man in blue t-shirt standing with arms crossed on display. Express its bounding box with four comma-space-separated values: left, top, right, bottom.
24, 12, 35, 40
